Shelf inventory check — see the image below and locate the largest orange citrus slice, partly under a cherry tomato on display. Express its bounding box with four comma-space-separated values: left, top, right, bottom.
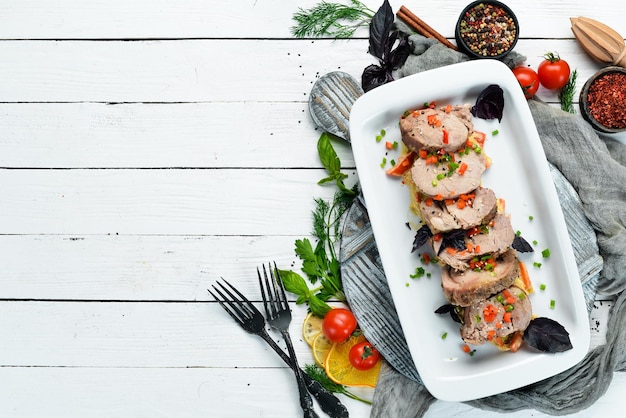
324, 335, 382, 388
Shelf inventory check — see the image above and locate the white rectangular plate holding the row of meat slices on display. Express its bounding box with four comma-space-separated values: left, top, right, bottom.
350, 60, 590, 401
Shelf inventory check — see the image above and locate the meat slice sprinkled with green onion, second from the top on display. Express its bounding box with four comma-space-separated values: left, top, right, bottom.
411, 150, 488, 200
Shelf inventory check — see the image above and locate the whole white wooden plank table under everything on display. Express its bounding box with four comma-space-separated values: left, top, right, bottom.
0, 0, 626, 417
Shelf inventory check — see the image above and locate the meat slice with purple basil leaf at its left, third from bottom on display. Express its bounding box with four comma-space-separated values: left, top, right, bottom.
432, 213, 515, 270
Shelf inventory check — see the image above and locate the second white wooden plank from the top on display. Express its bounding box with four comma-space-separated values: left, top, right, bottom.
0, 39, 601, 104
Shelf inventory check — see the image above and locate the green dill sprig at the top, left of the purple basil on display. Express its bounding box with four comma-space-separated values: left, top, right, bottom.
291, 0, 374, 39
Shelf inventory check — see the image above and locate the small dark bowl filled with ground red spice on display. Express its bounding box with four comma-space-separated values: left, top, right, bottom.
579, 66, 626, 133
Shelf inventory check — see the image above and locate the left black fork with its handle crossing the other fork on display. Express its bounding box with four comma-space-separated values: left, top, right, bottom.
207, 279, 348, 418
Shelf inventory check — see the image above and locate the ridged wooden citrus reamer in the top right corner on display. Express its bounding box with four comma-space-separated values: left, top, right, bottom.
570, 17, 626, 68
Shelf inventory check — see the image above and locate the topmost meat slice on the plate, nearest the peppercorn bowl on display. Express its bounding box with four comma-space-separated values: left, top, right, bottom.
400, 106, 474, 152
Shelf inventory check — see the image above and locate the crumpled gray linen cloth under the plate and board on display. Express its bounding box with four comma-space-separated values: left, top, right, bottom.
346, 35, 626, 417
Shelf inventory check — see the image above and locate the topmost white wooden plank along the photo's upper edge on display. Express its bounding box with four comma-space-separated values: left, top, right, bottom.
0, 0, 626, 40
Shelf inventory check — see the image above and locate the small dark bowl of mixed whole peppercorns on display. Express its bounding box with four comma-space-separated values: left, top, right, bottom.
454, 0, 519, 59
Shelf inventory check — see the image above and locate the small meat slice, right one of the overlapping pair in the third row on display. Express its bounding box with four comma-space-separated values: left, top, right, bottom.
446, 187, 497, 229
